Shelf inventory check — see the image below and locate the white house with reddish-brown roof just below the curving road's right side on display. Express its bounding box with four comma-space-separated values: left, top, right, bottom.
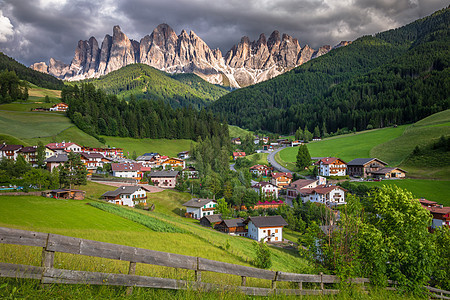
299, 185, 347, 206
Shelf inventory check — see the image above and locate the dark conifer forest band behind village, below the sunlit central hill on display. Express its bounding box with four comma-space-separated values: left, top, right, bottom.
61, 84, 229, 143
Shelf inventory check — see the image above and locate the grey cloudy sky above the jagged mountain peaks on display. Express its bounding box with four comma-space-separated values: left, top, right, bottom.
0, 0, 448, 66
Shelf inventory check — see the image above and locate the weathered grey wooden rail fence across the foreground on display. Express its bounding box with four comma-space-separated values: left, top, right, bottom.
0, 227, 450, 299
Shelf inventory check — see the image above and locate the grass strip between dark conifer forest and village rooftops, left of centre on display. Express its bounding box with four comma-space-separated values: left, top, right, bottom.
102, 136, 195, 157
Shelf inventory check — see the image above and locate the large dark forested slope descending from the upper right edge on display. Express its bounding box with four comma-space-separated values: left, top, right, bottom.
212, 8, 450, 133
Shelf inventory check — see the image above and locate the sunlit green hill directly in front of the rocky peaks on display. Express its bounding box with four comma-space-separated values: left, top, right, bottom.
85, 64, 227, 108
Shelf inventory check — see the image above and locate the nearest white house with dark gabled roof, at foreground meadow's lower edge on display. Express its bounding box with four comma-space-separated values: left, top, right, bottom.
244, 216, 288, 242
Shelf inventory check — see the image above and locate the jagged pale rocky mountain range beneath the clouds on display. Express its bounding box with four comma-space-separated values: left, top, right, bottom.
31, 24, 350, 87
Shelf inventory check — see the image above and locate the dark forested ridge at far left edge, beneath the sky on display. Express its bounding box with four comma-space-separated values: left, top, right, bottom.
0, 52, 64, 90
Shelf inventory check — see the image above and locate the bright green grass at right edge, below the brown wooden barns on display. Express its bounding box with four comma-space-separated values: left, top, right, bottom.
357, 179, 450, 206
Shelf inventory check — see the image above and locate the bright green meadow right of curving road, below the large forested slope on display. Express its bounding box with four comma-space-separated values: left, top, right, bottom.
279, 125, 407, 168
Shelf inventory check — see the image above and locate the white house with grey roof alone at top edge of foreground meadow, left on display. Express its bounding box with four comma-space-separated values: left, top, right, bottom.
102, 185, 148, 207
